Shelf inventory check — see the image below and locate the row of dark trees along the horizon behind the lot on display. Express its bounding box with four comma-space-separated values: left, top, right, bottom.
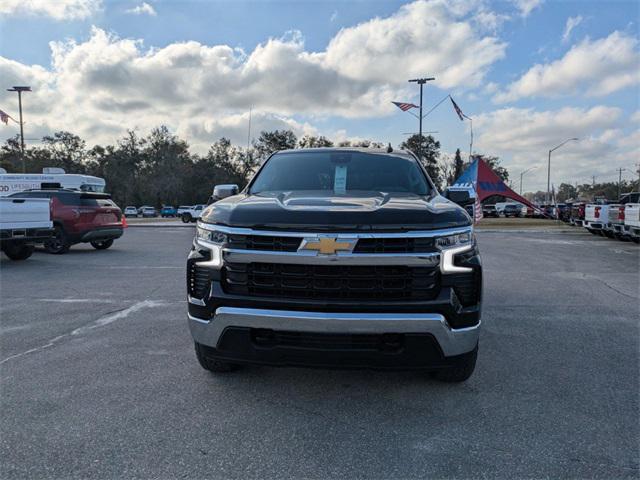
0, 126, 509, 206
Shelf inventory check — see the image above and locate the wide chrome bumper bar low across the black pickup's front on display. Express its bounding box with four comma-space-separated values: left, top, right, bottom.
189, 307, 480, 357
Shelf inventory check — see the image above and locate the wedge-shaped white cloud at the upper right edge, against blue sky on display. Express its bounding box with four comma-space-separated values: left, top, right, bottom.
494, 31, 640, 102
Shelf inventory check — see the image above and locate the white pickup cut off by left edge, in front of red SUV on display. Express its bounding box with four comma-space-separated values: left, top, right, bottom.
0, 198, 53, 260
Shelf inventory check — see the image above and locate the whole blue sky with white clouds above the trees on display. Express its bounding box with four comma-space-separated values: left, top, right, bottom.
0, 0, 640, 190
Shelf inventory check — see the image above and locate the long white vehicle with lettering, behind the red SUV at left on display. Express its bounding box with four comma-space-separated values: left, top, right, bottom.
0, 168, 105, 197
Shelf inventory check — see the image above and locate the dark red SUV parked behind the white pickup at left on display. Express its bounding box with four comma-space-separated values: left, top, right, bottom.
11, 188, 126, 254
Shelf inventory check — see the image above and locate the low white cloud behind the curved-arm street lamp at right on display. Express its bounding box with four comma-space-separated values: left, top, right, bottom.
474, 105, 640, 190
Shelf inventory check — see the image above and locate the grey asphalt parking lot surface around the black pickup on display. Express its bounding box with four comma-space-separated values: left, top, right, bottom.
0, 227, 640, 479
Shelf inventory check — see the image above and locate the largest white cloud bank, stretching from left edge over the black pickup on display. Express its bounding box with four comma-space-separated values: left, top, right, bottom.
0, 0, 505, 150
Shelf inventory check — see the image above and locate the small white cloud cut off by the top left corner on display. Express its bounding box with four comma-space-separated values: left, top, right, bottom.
0, 0, 102, 20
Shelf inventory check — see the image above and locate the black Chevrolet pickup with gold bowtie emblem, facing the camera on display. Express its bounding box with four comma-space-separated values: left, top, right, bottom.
187, 148, 482, 382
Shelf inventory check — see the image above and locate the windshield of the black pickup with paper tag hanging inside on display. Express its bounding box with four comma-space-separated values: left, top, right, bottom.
250, 151, 430, 195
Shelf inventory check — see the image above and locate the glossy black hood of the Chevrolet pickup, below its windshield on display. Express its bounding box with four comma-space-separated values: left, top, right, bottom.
202, 191, 471, 231
